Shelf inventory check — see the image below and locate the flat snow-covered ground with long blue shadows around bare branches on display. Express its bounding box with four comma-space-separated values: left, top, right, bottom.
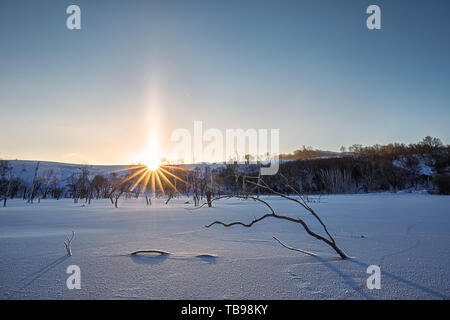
0, 194, 450, 299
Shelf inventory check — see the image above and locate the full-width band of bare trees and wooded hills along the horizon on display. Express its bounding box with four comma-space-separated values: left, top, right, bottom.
0, 137, 450, 206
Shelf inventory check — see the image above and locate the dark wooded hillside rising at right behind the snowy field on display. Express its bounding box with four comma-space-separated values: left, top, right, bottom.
219, 137, 450, 194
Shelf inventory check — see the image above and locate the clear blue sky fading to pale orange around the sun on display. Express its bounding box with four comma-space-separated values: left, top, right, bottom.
0, 0, 450, 164
